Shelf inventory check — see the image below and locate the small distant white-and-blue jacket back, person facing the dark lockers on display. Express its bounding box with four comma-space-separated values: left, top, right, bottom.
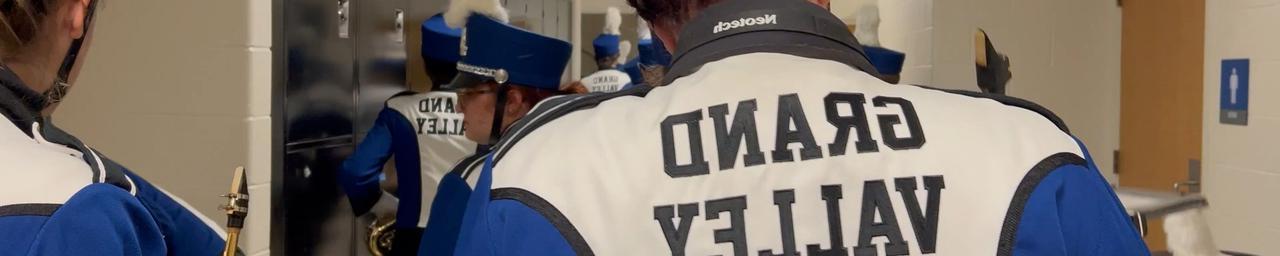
339, 91, 476, 229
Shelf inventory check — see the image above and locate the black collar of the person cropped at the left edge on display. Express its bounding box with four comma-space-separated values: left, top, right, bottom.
0, 65, 45, 136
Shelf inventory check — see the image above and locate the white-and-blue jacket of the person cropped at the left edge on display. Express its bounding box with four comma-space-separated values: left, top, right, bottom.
0, 102, 169, 255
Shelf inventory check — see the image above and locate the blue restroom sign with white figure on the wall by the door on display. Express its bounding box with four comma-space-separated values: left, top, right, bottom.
1219, 59, 1249, 125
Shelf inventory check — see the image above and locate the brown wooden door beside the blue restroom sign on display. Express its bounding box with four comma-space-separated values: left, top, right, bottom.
1117, 0, 1204, 251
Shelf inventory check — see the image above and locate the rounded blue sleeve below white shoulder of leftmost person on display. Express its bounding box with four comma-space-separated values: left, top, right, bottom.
19, 184, 167, 255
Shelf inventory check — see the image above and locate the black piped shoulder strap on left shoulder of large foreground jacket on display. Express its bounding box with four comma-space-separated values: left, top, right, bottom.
493, 86, 653, 161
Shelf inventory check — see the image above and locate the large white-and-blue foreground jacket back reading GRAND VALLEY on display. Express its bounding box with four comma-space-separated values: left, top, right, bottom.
454, 1, 1147, 255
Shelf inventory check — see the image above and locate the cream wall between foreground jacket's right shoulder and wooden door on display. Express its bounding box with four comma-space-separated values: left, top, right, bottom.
933, 0, 1120, 182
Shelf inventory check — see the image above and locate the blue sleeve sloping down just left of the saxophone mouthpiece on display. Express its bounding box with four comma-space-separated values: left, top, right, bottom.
125, 170, 227, 255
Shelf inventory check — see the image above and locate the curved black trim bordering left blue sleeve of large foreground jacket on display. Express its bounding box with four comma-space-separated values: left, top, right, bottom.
489, 188, 595, 256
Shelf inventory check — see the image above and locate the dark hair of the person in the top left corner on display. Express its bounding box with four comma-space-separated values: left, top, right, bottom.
0, 0, 65, 58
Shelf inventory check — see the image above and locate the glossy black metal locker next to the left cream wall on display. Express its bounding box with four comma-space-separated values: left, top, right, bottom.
279, 0, 356, 255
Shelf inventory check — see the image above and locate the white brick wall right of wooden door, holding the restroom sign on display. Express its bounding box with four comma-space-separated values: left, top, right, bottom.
1203, 0, 1280, 255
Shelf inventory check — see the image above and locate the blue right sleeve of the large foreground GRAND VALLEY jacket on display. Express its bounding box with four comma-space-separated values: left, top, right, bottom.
1014, 142, 1151, 256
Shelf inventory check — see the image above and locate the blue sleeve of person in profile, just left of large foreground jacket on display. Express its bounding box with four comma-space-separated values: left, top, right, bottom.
417, 173, 471, 256
